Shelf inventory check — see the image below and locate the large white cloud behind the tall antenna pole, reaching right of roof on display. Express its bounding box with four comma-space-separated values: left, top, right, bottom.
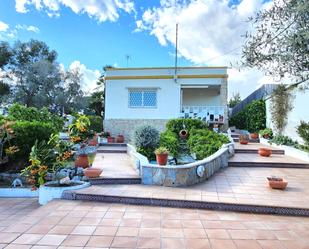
136, 0, 270, 97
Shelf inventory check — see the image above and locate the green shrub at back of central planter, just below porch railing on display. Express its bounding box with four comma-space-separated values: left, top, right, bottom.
166, 118, 208, 134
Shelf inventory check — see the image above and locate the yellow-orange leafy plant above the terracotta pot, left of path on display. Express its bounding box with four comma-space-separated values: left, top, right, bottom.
69, 115, 94, 143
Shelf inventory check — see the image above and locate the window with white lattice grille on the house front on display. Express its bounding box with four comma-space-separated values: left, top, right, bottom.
129, 89, 157, 108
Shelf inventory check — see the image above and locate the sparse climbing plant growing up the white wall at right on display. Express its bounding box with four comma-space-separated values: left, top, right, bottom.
270, 85, 293, 134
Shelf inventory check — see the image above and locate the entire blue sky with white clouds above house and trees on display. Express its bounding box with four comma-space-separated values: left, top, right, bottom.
0, 0, 271, 97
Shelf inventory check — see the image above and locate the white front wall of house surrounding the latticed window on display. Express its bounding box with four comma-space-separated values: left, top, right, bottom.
105, 79, 180, 119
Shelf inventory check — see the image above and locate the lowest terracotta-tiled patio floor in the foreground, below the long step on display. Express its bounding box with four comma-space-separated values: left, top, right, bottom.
0, 199, 309, 249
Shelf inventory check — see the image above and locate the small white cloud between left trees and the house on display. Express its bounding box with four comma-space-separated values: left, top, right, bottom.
69, 61, 101, 93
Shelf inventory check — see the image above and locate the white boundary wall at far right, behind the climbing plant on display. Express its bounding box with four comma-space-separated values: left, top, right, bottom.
266, 90, 309, 142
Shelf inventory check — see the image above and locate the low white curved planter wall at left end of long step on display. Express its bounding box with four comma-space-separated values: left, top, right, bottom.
39, 181, 90, 205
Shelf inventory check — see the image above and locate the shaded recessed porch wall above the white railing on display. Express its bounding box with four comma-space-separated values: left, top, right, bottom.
182, 88, 221, 106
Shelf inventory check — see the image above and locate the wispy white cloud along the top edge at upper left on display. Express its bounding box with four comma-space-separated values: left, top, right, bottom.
15, 0, 135, 22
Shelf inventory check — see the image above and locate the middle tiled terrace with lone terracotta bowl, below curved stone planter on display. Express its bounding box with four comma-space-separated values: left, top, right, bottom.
75, 167, 309, 208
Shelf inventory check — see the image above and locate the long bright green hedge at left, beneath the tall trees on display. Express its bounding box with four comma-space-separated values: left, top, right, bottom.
8, 104, 64, 131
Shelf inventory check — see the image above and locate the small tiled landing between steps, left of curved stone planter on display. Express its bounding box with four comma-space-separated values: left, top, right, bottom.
92, 153, 139, 178
